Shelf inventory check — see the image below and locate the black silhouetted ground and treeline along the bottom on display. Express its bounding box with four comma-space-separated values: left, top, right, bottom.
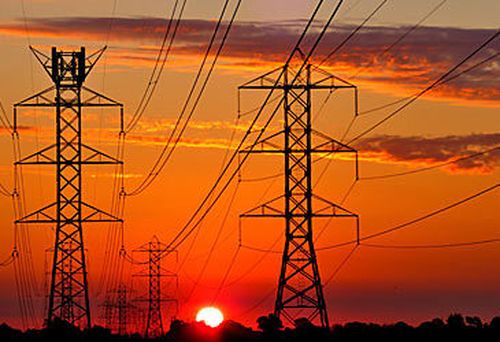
0, 314, 500, 342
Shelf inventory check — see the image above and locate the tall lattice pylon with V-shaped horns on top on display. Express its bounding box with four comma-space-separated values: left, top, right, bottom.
14, 47, 123, 327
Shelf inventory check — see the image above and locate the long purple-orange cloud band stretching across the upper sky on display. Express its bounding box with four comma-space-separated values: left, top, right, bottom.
0, 17, 500, 105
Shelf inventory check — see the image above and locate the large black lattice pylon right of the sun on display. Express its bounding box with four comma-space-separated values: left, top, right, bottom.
239, 60, 359, 327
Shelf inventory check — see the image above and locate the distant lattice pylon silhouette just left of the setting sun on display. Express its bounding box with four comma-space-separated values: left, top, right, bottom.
134, 236, 178, 338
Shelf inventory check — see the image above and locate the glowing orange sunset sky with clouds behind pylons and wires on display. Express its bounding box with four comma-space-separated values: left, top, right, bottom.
0, 0, 500, 332
